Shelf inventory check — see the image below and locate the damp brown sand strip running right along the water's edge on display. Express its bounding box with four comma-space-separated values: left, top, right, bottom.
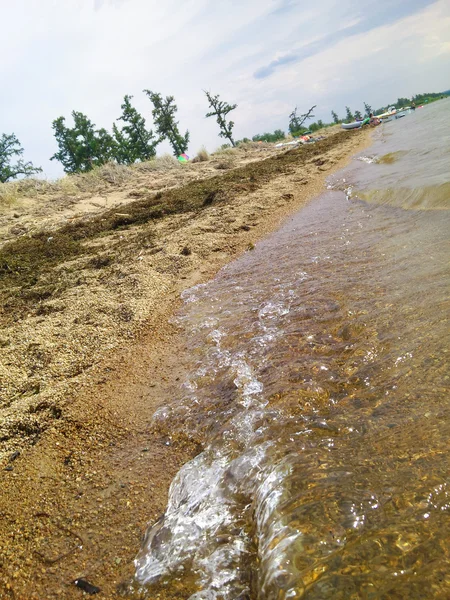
0, 131, 371, 600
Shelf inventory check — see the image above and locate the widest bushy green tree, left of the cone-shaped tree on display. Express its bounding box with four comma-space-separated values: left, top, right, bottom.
50, 110, 115, 173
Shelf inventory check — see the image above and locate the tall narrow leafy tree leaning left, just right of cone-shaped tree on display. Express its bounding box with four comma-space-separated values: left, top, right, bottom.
144, 90, 189, 156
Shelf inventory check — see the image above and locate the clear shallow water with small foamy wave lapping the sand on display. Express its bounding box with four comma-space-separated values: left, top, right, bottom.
136, 100, 450, 600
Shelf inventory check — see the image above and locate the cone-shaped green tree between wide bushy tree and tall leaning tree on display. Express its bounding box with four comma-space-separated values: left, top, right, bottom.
113, 96, 160, 165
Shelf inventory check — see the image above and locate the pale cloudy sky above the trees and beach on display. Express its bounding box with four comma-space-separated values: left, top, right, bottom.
0, 0, 450, 178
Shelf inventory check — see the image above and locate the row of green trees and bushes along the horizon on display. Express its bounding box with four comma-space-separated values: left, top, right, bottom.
0, 90, 450, 183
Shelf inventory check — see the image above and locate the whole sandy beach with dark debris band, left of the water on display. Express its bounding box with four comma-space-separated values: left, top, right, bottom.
0, 130, 370, 600
